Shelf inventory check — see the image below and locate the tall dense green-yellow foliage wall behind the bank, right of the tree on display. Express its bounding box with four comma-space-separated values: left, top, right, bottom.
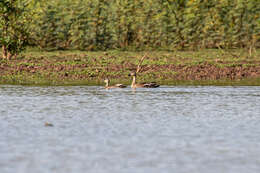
1, 0, 260, 53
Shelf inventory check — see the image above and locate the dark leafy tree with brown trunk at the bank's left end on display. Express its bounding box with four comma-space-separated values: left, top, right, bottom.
0, 0, 29, 59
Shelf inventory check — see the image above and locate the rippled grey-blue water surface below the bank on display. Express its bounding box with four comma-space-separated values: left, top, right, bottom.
0, 86, 260, 173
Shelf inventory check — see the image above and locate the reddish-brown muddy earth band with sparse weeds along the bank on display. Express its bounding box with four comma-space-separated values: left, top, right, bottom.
0, 53, 260, 84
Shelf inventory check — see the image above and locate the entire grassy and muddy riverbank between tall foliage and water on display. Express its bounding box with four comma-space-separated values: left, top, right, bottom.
0, 50, 260, 85
